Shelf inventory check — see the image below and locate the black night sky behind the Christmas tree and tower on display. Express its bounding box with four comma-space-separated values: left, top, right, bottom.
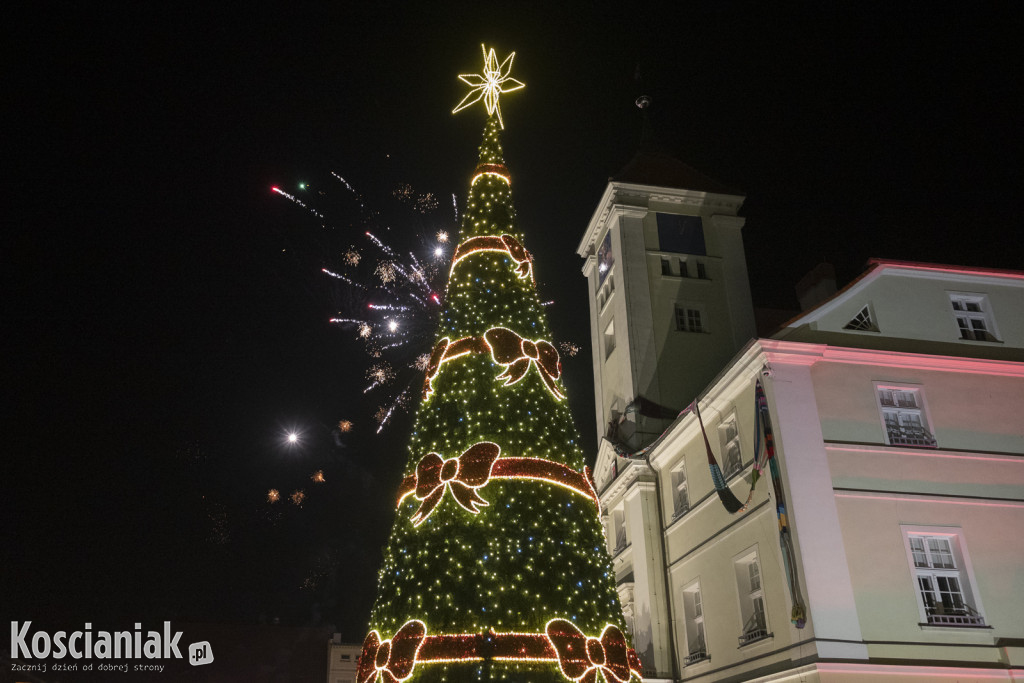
0, 2, 1024, 655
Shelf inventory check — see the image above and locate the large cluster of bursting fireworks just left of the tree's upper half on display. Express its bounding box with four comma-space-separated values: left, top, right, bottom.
273, 173, 458, 433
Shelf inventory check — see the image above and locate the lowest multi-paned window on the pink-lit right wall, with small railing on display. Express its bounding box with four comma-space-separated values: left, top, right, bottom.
904, 528, 985, 626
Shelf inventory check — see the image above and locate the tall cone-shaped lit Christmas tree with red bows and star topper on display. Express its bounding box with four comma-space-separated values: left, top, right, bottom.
358, 49, 640, 683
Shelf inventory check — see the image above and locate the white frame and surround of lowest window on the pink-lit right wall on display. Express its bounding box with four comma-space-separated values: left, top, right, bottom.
900, 524, 988, 629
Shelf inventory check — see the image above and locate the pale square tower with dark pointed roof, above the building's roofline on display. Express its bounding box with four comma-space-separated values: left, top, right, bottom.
577, 111, 756, 451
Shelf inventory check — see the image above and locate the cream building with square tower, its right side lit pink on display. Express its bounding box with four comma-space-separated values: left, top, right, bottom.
579, 158, 1024, 682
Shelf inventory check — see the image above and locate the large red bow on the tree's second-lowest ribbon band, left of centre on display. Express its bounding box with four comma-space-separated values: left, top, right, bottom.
413, 441, 502, 526
